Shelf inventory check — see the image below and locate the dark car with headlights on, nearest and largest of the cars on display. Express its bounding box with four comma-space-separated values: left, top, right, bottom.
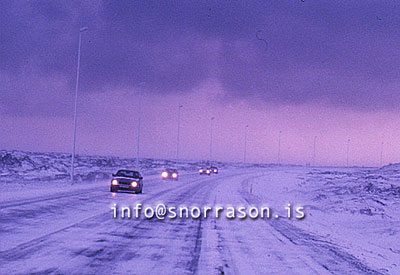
111, 170, 143, 193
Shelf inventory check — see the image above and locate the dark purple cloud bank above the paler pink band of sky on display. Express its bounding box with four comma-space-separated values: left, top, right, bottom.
0, 0, 400, 114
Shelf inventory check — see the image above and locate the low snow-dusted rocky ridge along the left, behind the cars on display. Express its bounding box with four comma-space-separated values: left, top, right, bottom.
0, 150, 262, 182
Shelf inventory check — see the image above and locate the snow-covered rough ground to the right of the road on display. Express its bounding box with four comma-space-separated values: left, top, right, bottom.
242, 168, 400, 274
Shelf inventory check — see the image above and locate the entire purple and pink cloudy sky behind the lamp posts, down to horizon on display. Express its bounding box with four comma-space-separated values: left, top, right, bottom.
0, 0, 400, 165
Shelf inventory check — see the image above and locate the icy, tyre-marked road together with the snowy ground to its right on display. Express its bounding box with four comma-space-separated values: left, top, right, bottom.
0, 167, 400, 274
